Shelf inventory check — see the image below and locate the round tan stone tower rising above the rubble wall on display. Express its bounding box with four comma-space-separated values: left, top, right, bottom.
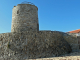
11, 1, 39, 33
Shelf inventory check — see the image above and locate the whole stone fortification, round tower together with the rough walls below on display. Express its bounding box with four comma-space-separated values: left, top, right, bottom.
0, 1, 79, 60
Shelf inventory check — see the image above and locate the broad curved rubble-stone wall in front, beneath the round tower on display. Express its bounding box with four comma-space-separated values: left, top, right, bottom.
0, 31, 72, 60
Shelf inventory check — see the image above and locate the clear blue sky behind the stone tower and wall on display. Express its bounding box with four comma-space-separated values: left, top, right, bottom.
0, 0, 80, 33
